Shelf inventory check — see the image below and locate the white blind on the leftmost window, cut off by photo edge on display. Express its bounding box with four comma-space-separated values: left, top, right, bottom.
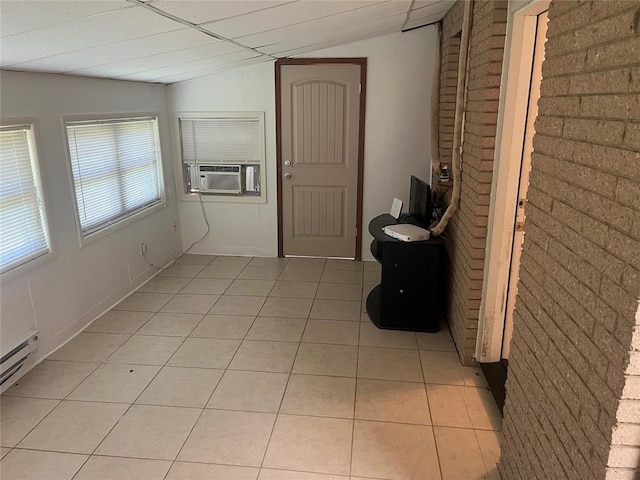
0, 125, 49, 272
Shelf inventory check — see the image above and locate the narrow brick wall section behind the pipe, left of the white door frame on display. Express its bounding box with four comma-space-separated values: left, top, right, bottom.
440, 0, 507, 364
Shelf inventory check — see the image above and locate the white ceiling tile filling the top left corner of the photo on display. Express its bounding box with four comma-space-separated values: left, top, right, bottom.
0, 0, 131, 38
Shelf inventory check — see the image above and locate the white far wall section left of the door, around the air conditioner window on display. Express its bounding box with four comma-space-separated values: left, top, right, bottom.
167, 63, 278, 256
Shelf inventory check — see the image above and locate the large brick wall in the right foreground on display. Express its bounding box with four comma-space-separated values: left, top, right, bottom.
499, 0, 640, 480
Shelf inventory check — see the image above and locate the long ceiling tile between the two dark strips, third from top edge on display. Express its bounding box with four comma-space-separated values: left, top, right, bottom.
236, 2, 406, 51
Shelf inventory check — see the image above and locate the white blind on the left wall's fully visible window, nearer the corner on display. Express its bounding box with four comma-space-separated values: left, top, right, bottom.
67, 118, 163, 236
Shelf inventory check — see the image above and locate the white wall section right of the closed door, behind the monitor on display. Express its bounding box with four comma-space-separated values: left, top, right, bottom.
303, 26, 439, 259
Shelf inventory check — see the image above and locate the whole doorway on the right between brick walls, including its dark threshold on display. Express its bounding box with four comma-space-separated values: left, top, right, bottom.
476, 0, 549, 409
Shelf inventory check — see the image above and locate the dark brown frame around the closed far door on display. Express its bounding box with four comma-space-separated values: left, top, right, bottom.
275, 58, 367, 260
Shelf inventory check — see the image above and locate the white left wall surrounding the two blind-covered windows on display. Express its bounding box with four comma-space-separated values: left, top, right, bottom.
0, 71, 181, 376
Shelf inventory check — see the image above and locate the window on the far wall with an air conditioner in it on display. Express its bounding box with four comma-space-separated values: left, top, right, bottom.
178, 112, 266, 202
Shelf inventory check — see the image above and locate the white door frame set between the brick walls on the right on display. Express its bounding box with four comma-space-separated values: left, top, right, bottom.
475, 0, 550, 363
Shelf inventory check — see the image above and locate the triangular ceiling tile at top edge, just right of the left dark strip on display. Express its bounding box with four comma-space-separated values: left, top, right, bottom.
151, 0, 291, 25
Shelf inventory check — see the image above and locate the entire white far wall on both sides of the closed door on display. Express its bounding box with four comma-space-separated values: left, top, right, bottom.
168, 27, 437, 258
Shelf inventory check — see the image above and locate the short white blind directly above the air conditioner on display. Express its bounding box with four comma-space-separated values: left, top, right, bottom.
180, 116, 264, 164
